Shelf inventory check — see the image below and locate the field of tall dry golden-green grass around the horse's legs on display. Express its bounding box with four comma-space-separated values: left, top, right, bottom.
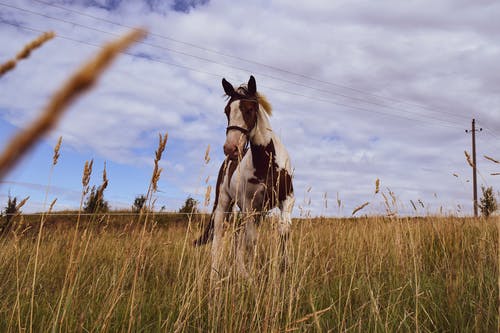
0, 215, 499, 332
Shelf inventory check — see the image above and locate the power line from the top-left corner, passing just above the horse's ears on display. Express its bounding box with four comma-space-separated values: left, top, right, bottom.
0, 0, 468, 128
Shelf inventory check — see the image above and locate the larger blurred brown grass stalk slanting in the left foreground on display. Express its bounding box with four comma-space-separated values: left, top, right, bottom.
0, 29, 146, 179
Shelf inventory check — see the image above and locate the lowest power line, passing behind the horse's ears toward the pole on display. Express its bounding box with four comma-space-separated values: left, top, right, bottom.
0, 18, 462, 129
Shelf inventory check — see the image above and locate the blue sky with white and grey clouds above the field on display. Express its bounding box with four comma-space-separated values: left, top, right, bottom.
0, 0, 500, 216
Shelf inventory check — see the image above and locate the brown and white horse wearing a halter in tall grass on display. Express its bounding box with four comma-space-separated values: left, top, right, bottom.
194, 76, 295, 279
